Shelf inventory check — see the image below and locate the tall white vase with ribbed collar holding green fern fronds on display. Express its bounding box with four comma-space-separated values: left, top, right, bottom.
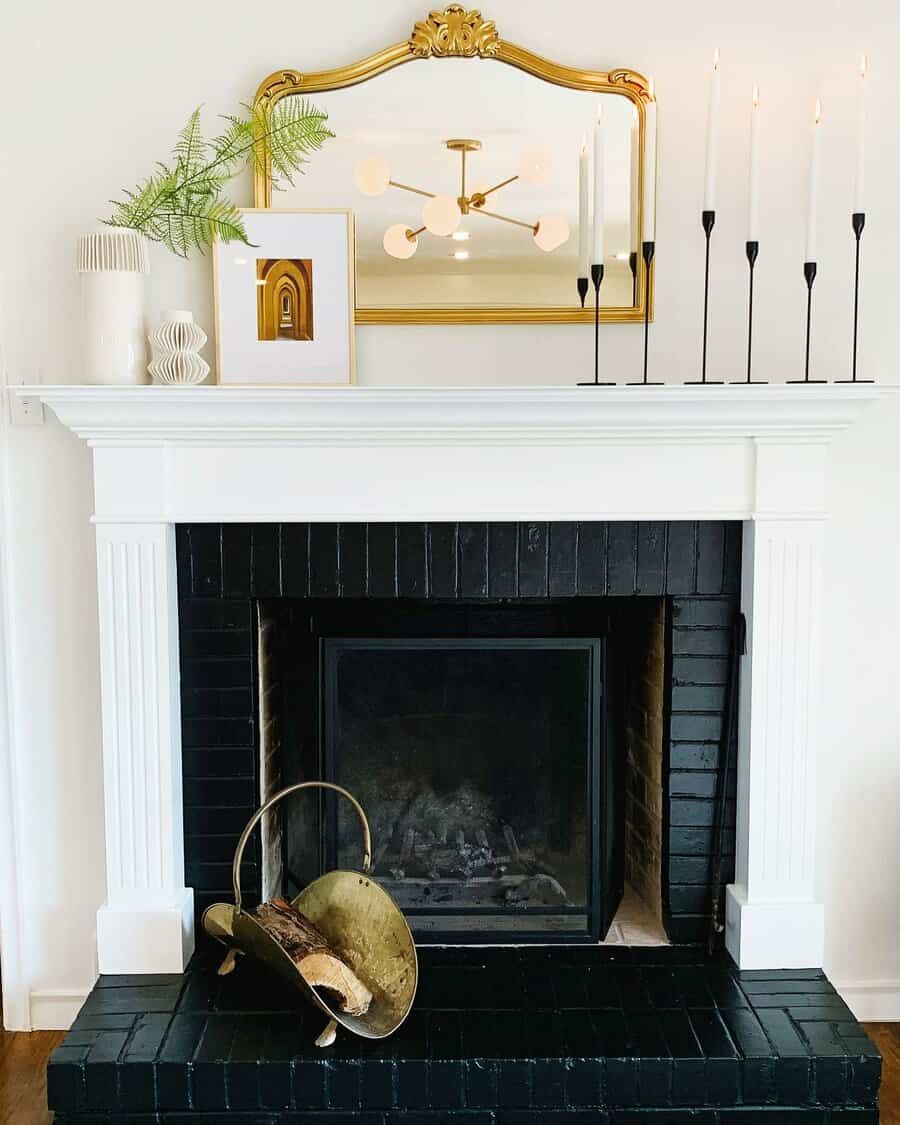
78, 227, 150, 386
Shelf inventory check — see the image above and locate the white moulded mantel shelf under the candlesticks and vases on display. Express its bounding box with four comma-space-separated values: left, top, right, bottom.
14, 384, 893, 446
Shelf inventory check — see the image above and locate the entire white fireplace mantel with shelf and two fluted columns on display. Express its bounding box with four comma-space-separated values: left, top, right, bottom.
18, 385, 879, 972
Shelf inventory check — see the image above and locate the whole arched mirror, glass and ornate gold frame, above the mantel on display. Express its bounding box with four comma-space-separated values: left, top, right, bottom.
254, 5, 653, 324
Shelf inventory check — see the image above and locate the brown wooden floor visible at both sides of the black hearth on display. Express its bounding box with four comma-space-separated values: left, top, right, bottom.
0, 1024, 900, 1125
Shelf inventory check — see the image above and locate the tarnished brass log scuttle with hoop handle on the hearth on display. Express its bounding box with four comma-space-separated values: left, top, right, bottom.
203, 781, 419, 1046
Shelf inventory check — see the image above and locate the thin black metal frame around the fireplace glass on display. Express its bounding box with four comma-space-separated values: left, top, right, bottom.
318, 636, 614, 945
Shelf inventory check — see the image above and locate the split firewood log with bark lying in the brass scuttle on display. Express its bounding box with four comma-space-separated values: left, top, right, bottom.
253, 899, 372, 1016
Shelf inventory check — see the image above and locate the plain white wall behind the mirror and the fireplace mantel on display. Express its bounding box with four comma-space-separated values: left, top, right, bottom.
0, 0, 900, 1026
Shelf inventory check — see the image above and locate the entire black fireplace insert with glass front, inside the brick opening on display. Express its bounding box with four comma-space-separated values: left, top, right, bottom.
260, 600, 623, 942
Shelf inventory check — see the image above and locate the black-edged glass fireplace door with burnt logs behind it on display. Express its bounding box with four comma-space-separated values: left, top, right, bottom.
320, 637, 603, 942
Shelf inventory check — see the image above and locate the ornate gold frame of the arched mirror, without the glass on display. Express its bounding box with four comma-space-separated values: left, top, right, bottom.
253, 3, 653, 324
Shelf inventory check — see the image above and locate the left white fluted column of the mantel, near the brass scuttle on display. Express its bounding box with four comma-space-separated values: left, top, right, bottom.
97, 523, 194, 973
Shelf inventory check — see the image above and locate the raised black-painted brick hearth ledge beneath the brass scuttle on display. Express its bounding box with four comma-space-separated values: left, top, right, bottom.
48, 946, 881, 1125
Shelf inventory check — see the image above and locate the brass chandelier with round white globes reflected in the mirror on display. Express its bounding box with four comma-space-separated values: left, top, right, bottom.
356, 137, 569, 259
